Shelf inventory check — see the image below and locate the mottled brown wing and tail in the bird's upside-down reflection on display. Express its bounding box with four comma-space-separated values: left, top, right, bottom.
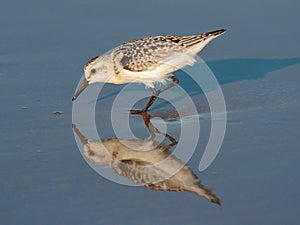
111, 155, 221, 204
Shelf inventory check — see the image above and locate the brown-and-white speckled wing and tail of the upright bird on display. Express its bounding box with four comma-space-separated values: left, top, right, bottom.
113, 30, 225, 72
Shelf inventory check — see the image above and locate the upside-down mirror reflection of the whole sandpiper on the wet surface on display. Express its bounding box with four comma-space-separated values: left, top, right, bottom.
73, 113, 221, 204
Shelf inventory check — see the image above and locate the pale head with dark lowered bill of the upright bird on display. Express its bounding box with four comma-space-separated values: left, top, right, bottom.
72, 55, 114, 101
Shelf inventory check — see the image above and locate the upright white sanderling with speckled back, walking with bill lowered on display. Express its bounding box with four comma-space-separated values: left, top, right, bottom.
72, 29, 226, 113
